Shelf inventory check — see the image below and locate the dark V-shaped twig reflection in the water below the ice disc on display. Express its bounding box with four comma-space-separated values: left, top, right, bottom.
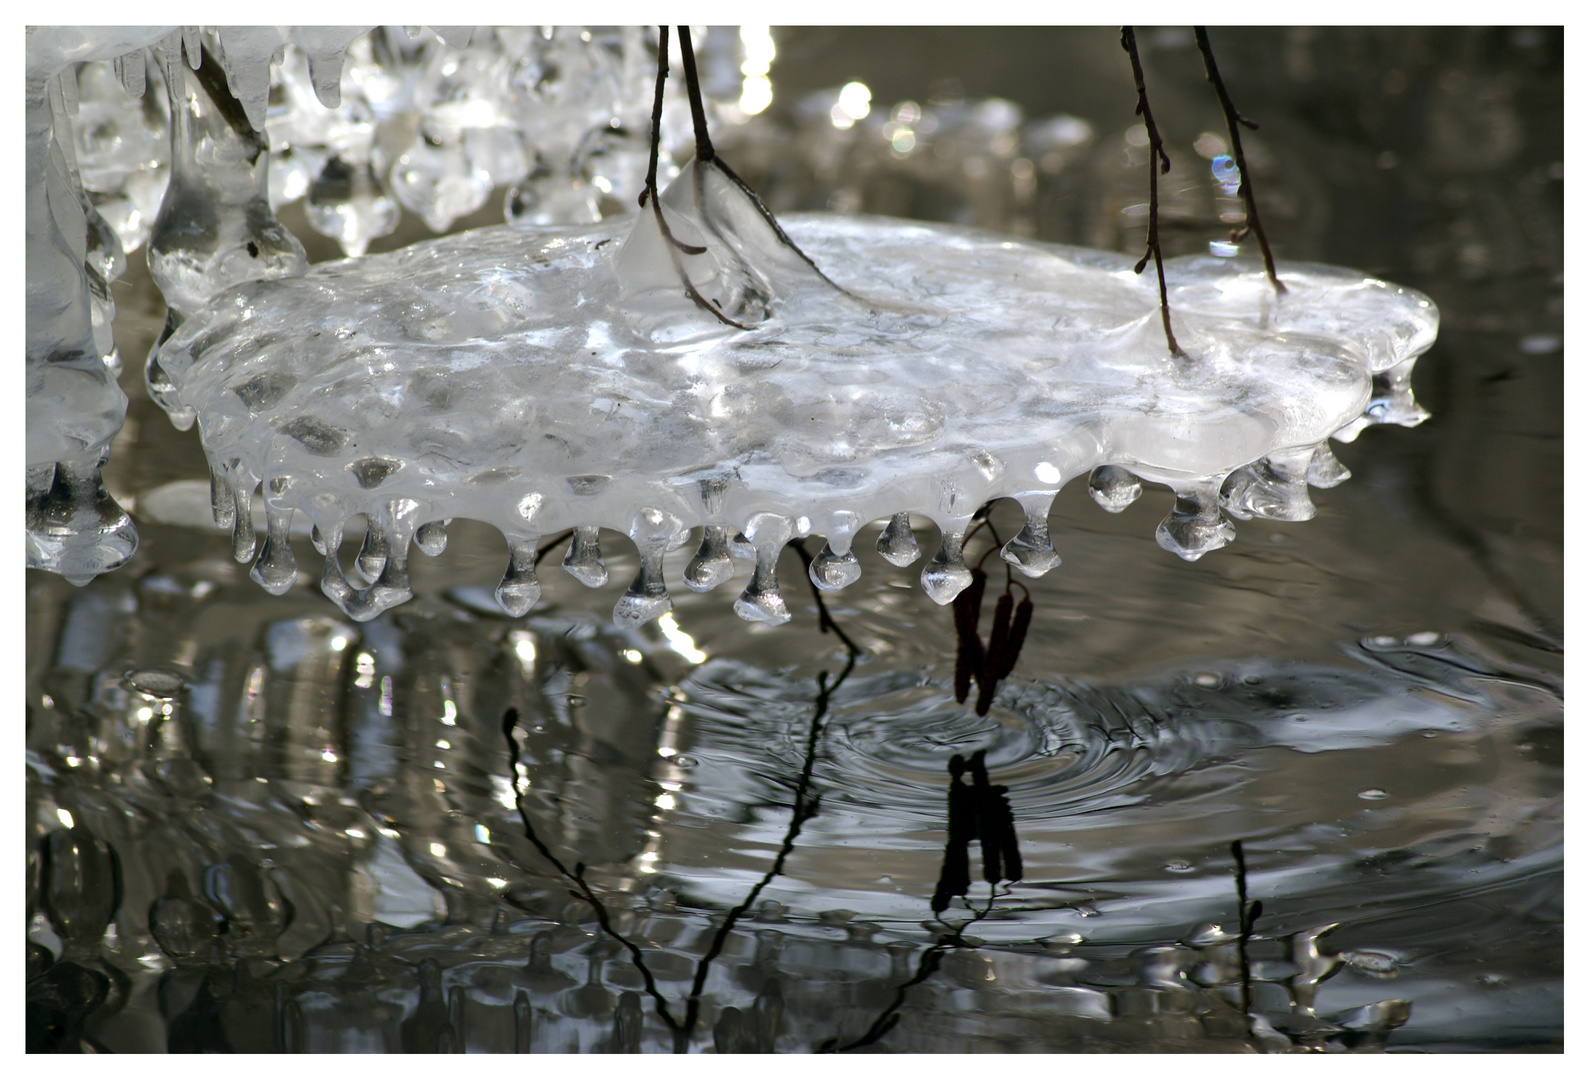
502, 539, 864, 1053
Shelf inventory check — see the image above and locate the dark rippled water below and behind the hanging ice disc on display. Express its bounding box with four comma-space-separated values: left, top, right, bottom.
25, 29, 1563, 1053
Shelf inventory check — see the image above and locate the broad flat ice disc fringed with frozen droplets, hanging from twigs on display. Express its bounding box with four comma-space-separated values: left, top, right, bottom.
151, 162, 1437, 624
